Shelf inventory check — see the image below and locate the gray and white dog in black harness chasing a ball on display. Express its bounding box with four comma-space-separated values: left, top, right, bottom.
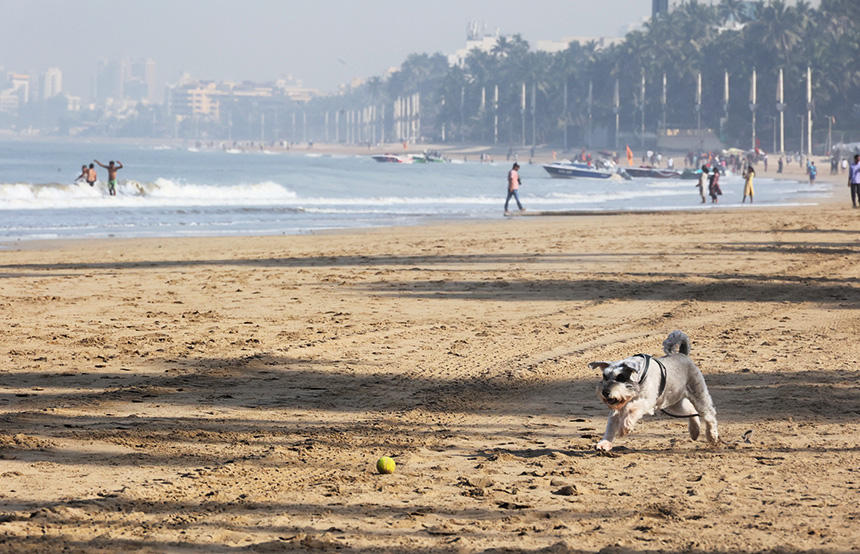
588, 331, 719, 452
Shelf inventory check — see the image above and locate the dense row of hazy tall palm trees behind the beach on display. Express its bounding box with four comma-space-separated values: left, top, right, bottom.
309, 0, 860, 149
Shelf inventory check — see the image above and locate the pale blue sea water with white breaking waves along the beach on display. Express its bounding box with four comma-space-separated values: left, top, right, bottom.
0, 141, 829, 242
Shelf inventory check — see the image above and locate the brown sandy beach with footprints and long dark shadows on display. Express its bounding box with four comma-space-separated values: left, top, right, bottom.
0, 197, 860, 552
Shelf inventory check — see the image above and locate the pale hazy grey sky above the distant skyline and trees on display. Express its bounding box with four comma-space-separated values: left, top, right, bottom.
0, 0, 651, 98
